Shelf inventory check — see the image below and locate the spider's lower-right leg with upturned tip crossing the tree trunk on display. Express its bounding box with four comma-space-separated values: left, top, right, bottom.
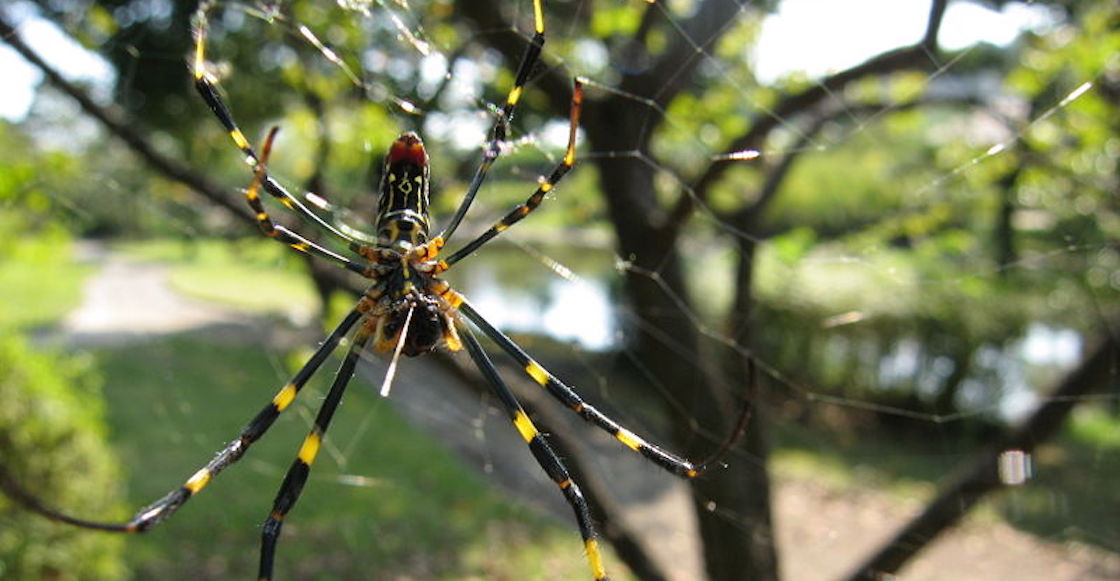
458, 296, 753, 478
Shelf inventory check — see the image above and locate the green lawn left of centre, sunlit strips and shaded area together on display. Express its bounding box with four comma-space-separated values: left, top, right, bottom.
0, 235, 640, 580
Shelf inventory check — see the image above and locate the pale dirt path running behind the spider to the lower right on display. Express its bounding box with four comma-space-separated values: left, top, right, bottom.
63, 246, 1120, 581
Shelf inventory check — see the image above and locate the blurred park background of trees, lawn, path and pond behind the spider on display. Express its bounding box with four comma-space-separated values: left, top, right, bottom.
0, 0, 1120, 581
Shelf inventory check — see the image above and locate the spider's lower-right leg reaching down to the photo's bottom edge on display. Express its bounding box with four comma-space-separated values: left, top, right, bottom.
459, 326, 608, 581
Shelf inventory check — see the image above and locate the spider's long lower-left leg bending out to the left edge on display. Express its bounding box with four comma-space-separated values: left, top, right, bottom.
0, 309, 362, 533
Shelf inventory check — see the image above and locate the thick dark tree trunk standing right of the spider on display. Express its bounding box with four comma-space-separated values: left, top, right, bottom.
584, 92, 776, 581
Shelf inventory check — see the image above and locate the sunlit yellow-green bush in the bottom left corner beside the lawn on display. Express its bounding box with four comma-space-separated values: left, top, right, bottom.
0, 332, 124, 581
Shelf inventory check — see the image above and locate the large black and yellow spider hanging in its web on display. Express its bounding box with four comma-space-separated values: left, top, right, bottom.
0, 0, 748, 580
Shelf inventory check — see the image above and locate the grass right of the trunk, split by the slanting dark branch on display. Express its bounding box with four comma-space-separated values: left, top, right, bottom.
772, 411, 1120, 551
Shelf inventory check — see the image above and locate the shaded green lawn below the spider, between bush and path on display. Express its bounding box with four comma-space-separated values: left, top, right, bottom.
90, 336, 620, 579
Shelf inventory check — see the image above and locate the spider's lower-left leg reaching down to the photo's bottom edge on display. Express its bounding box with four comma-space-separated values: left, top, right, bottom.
258, 328, 370, 581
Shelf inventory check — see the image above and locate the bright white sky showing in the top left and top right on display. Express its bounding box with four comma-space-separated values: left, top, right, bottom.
0, 0, 1048, 121
